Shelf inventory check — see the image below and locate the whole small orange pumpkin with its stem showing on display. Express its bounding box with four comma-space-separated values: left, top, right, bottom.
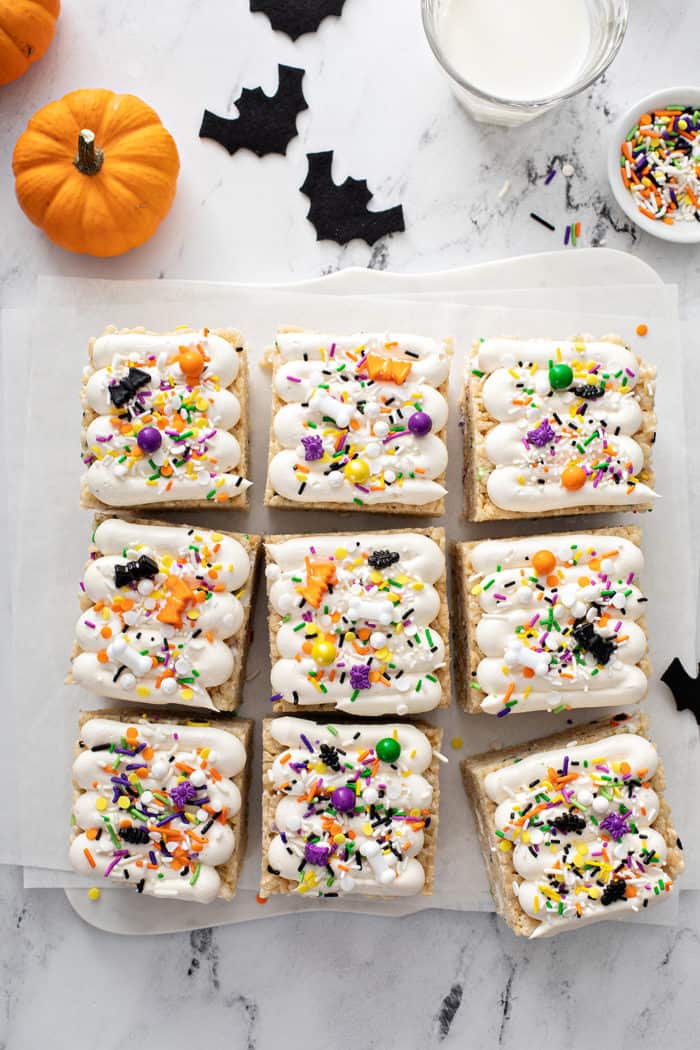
13, 89, 179, 256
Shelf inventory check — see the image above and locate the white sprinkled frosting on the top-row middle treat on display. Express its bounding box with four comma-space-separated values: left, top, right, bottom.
265, 332, 451, 506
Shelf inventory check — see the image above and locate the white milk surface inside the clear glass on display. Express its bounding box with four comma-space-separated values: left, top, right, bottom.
438, 0, 591, 102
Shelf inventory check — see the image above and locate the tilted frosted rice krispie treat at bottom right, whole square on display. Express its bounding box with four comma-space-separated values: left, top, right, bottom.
462, 715, 683, 938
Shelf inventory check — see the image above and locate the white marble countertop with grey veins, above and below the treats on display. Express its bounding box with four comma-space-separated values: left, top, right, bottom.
0, 0, 700, 1050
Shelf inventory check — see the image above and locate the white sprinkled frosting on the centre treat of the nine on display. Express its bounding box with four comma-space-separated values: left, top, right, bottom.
267, 532, 445, 715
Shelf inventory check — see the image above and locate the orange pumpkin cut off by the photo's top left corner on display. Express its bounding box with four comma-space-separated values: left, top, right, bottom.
0, 0, 61, 86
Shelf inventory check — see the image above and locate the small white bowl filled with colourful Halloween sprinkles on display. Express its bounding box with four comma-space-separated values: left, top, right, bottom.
608, 87, 700, 244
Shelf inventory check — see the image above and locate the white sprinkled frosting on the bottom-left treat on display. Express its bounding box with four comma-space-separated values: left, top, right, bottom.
70, 718, 247, 903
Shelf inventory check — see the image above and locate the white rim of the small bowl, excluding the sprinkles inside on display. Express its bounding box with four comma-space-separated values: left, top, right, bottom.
608, 87, 700, 245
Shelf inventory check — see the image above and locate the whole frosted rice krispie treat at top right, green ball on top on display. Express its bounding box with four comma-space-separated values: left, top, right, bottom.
464, 336, 656, 521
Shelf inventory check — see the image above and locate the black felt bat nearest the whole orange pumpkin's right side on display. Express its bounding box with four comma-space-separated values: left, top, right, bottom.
199, 65, 309, 156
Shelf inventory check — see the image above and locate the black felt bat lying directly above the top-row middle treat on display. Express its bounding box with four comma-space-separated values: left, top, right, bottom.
300, 150, 406, 245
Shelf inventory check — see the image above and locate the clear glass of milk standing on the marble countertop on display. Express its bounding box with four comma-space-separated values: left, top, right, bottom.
423, 0, 629, 125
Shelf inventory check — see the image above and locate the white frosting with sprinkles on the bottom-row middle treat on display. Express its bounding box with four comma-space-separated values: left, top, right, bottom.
268, 718, 432, 897
